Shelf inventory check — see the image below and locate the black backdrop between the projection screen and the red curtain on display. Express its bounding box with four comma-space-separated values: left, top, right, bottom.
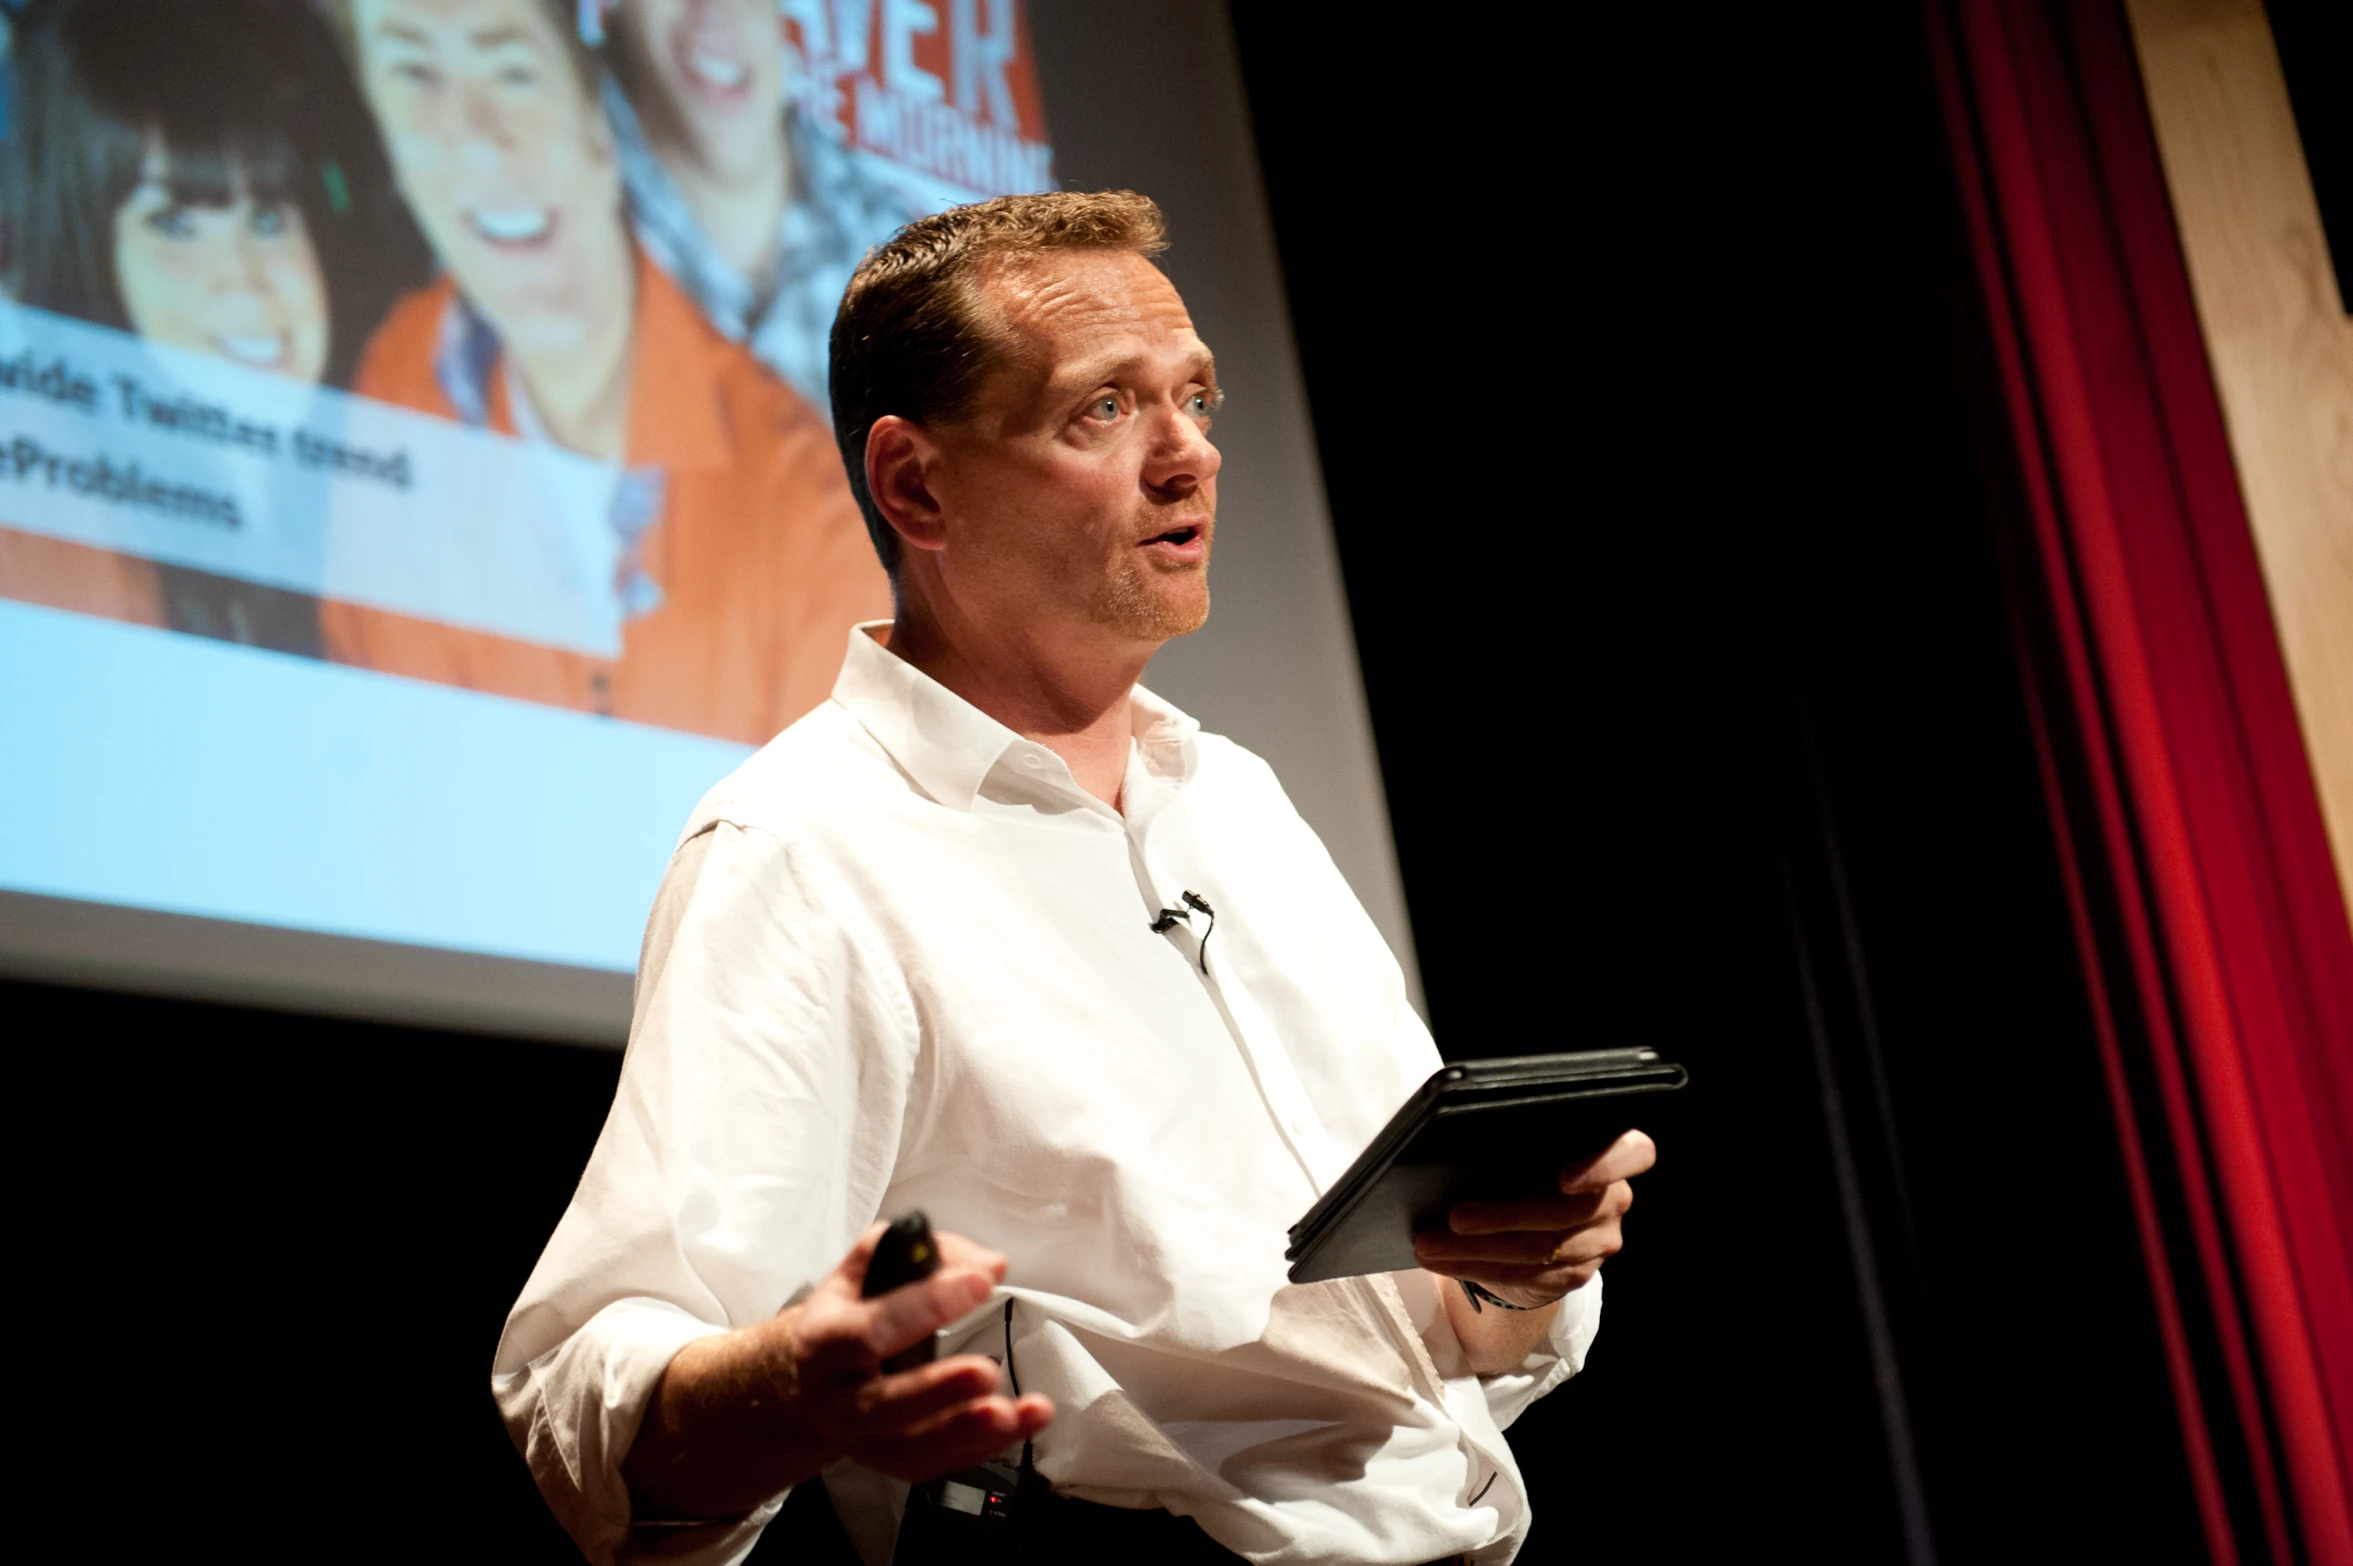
1233, 5, 2202, 1561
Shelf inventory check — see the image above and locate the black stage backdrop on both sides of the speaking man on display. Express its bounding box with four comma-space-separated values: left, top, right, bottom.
0, 7, 2198, 1561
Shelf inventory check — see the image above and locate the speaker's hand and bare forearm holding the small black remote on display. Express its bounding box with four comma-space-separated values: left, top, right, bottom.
621, 1223, 1054, 1517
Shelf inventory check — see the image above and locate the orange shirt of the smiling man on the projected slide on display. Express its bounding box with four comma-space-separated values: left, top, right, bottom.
320, 256, 889, 745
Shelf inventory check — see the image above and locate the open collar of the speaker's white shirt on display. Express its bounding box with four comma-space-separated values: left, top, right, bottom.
833, 621, 1200, 811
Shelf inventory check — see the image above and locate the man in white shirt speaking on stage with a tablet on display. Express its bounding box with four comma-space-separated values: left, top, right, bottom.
494, 193, 1652, 1566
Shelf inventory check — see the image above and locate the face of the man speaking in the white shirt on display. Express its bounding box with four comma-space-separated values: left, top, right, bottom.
929, 249, 1219, 644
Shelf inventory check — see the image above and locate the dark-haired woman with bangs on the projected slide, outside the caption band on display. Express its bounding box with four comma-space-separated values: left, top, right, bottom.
0, 0, 421, 656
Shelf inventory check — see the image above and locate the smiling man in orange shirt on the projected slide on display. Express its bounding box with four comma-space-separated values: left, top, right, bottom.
325, 0, 887, 743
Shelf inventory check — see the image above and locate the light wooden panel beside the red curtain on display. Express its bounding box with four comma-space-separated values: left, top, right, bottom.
2127, 0, 2353, 908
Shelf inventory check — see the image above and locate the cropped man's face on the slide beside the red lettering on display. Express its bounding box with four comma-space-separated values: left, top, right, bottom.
612, 0, 784, 181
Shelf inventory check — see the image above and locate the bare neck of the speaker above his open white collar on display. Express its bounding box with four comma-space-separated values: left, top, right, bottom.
889, 583, 1158, 809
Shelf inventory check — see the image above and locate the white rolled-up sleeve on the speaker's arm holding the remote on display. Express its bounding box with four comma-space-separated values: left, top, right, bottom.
492, 821, 915, 1566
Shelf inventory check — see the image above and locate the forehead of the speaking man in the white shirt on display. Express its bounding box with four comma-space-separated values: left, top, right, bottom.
981, 249, 1205, 379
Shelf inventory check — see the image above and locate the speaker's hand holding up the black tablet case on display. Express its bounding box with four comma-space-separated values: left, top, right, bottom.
1414, 1131, 1659, 1376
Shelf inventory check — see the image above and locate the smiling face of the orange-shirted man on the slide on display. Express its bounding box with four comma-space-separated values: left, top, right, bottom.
353, 0, 626, 350
